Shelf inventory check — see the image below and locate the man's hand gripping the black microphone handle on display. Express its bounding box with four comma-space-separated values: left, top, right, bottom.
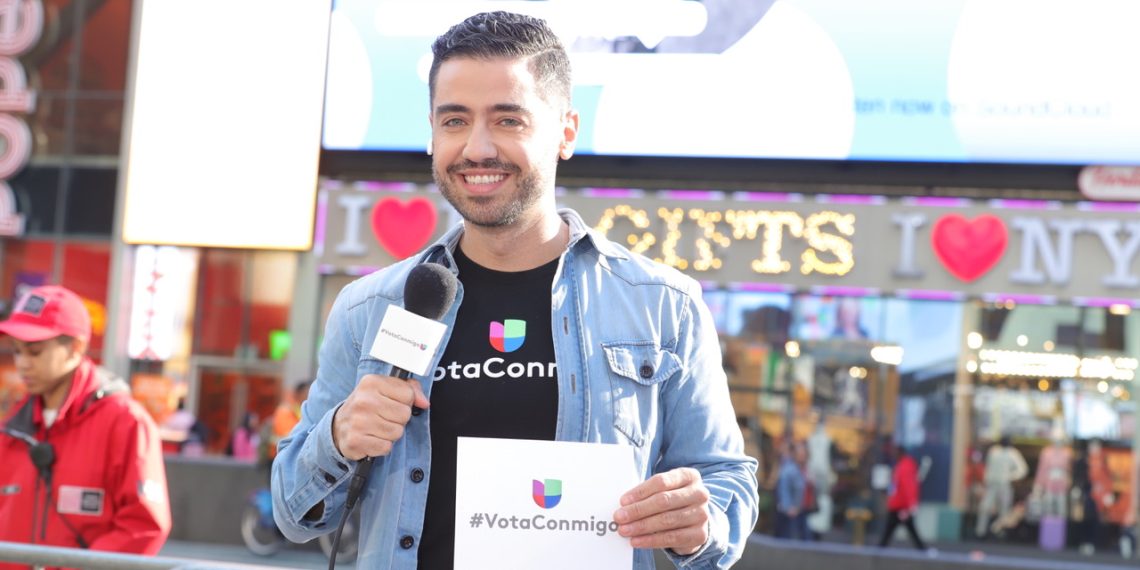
333, 374, 429, 461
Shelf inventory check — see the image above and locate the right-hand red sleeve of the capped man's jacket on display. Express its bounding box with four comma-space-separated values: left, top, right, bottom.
88, 397, 171, 554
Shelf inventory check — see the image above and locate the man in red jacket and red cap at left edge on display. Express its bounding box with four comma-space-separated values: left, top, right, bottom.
0, 285, 171, 569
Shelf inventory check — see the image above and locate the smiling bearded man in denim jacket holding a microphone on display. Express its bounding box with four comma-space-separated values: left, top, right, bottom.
274, 13, 757, 569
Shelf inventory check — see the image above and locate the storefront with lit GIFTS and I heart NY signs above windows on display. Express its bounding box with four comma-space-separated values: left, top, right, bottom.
314, 180, 1140, 535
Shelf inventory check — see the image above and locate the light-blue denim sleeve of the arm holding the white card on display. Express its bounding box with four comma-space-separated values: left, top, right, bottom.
654, 287, 759, 569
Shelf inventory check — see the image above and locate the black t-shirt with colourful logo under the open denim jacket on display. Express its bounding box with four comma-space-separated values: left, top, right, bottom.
418, 249, 559, 570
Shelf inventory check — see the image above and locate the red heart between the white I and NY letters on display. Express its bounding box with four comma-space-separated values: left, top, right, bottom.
930, 214, 1009, 282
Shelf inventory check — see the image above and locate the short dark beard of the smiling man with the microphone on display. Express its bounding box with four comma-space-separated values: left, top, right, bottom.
431, 161, 543, 228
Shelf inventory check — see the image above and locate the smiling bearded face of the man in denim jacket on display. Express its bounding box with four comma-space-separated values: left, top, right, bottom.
429, 57, 578, 227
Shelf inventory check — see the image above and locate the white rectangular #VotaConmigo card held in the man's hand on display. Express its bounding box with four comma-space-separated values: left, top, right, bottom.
455, 438, 641, 570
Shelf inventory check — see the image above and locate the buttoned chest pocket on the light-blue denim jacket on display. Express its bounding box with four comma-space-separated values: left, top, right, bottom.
602, 341, 681, 447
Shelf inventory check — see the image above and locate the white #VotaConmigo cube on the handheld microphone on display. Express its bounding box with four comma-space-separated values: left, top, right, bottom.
368, 304, 447, 376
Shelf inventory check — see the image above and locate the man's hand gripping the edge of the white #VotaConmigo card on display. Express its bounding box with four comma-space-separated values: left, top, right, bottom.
613, 467, 709, 556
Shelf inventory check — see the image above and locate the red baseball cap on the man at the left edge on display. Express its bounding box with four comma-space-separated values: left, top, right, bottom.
0, 285, 91, 342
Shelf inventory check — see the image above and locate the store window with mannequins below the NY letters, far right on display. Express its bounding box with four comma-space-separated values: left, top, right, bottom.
967, 302, 1140, 552
